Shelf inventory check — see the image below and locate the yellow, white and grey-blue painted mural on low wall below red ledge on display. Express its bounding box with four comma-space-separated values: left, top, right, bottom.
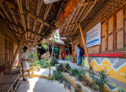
83, 57, 126, 83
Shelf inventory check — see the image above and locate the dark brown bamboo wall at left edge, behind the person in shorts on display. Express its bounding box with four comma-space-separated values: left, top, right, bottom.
0, 32, 18, 71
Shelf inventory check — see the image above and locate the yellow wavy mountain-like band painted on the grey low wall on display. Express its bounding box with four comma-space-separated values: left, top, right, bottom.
91, 59, 126, 83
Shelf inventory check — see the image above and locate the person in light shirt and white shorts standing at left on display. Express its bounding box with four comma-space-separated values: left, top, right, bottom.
20, 47, 30, 81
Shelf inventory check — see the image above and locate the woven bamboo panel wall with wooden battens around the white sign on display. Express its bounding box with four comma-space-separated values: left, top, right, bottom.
74, 6, 126, 54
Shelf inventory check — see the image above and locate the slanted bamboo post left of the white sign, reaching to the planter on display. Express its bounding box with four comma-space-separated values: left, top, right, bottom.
79, 24, 91, 68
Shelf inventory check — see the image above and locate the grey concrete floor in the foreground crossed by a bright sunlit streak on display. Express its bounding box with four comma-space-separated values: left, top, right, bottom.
17, 78, 68, 92
